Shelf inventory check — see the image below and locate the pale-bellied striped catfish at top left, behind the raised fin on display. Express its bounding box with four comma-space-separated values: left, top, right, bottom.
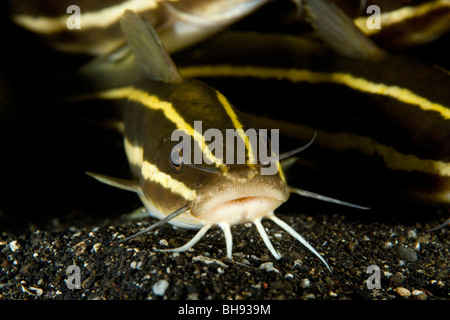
5, 0, 268, 56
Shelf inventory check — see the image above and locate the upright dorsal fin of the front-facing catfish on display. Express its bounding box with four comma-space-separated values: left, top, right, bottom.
120, 10, 181, 83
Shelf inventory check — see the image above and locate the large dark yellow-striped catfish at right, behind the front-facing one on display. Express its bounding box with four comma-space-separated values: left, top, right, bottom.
171, 1, 450, 207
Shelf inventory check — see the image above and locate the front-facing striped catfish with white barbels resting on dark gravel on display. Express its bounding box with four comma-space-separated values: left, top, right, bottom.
83, 11, 367, 271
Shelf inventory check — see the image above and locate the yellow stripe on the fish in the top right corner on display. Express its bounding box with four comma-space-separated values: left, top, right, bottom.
354, 0, 450, 36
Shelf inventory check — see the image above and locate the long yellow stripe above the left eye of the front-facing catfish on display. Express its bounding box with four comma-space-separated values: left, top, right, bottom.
96, 87, 222, 166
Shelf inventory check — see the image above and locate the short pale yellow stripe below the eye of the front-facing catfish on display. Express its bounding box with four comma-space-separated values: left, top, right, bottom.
141, 161, 197, 201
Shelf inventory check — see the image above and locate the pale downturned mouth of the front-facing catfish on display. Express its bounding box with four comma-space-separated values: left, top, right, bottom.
191, 188, 289, 225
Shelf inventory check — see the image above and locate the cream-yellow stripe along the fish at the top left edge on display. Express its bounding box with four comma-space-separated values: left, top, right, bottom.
13, 0, 163, 34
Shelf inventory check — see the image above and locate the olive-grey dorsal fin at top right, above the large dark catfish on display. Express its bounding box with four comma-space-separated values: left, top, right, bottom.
304, 0, 385, 61
